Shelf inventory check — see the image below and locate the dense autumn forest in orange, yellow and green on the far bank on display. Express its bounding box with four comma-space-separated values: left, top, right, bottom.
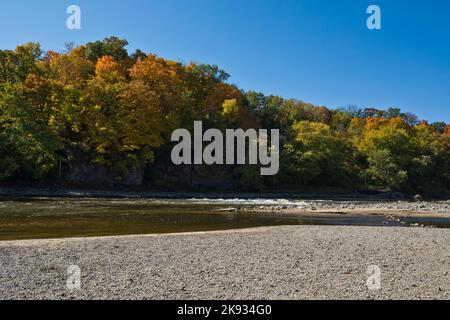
0, 37, 450, 195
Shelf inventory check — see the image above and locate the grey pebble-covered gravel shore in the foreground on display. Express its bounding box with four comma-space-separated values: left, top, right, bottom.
0, 226, 450, 299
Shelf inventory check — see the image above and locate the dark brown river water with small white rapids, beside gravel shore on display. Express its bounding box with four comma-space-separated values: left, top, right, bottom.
0, 198, 450, 240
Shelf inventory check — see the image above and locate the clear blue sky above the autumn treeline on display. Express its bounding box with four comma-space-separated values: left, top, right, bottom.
0, 0, 450, 123
